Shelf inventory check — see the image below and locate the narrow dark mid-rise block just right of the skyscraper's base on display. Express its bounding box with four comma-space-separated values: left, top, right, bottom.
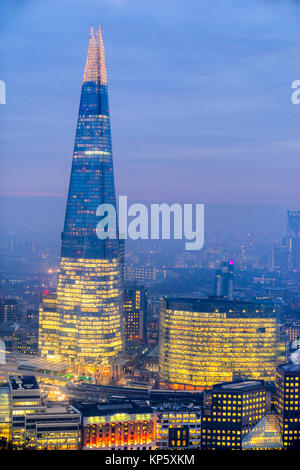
124, 285, 148, 341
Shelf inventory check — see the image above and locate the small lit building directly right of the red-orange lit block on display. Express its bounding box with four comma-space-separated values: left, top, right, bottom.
155, 406, 201, 450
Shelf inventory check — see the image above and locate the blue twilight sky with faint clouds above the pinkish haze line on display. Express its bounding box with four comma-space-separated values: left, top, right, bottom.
0, 0, 300, 208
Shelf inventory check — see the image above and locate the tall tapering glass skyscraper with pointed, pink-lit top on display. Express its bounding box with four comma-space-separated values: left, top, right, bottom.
39, 28, 123, 376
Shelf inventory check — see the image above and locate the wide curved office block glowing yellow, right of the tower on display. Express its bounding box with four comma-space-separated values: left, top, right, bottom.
159, 298, 284, 390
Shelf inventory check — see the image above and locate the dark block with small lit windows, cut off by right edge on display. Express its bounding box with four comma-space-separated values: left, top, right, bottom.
276, 362, 300, 449
